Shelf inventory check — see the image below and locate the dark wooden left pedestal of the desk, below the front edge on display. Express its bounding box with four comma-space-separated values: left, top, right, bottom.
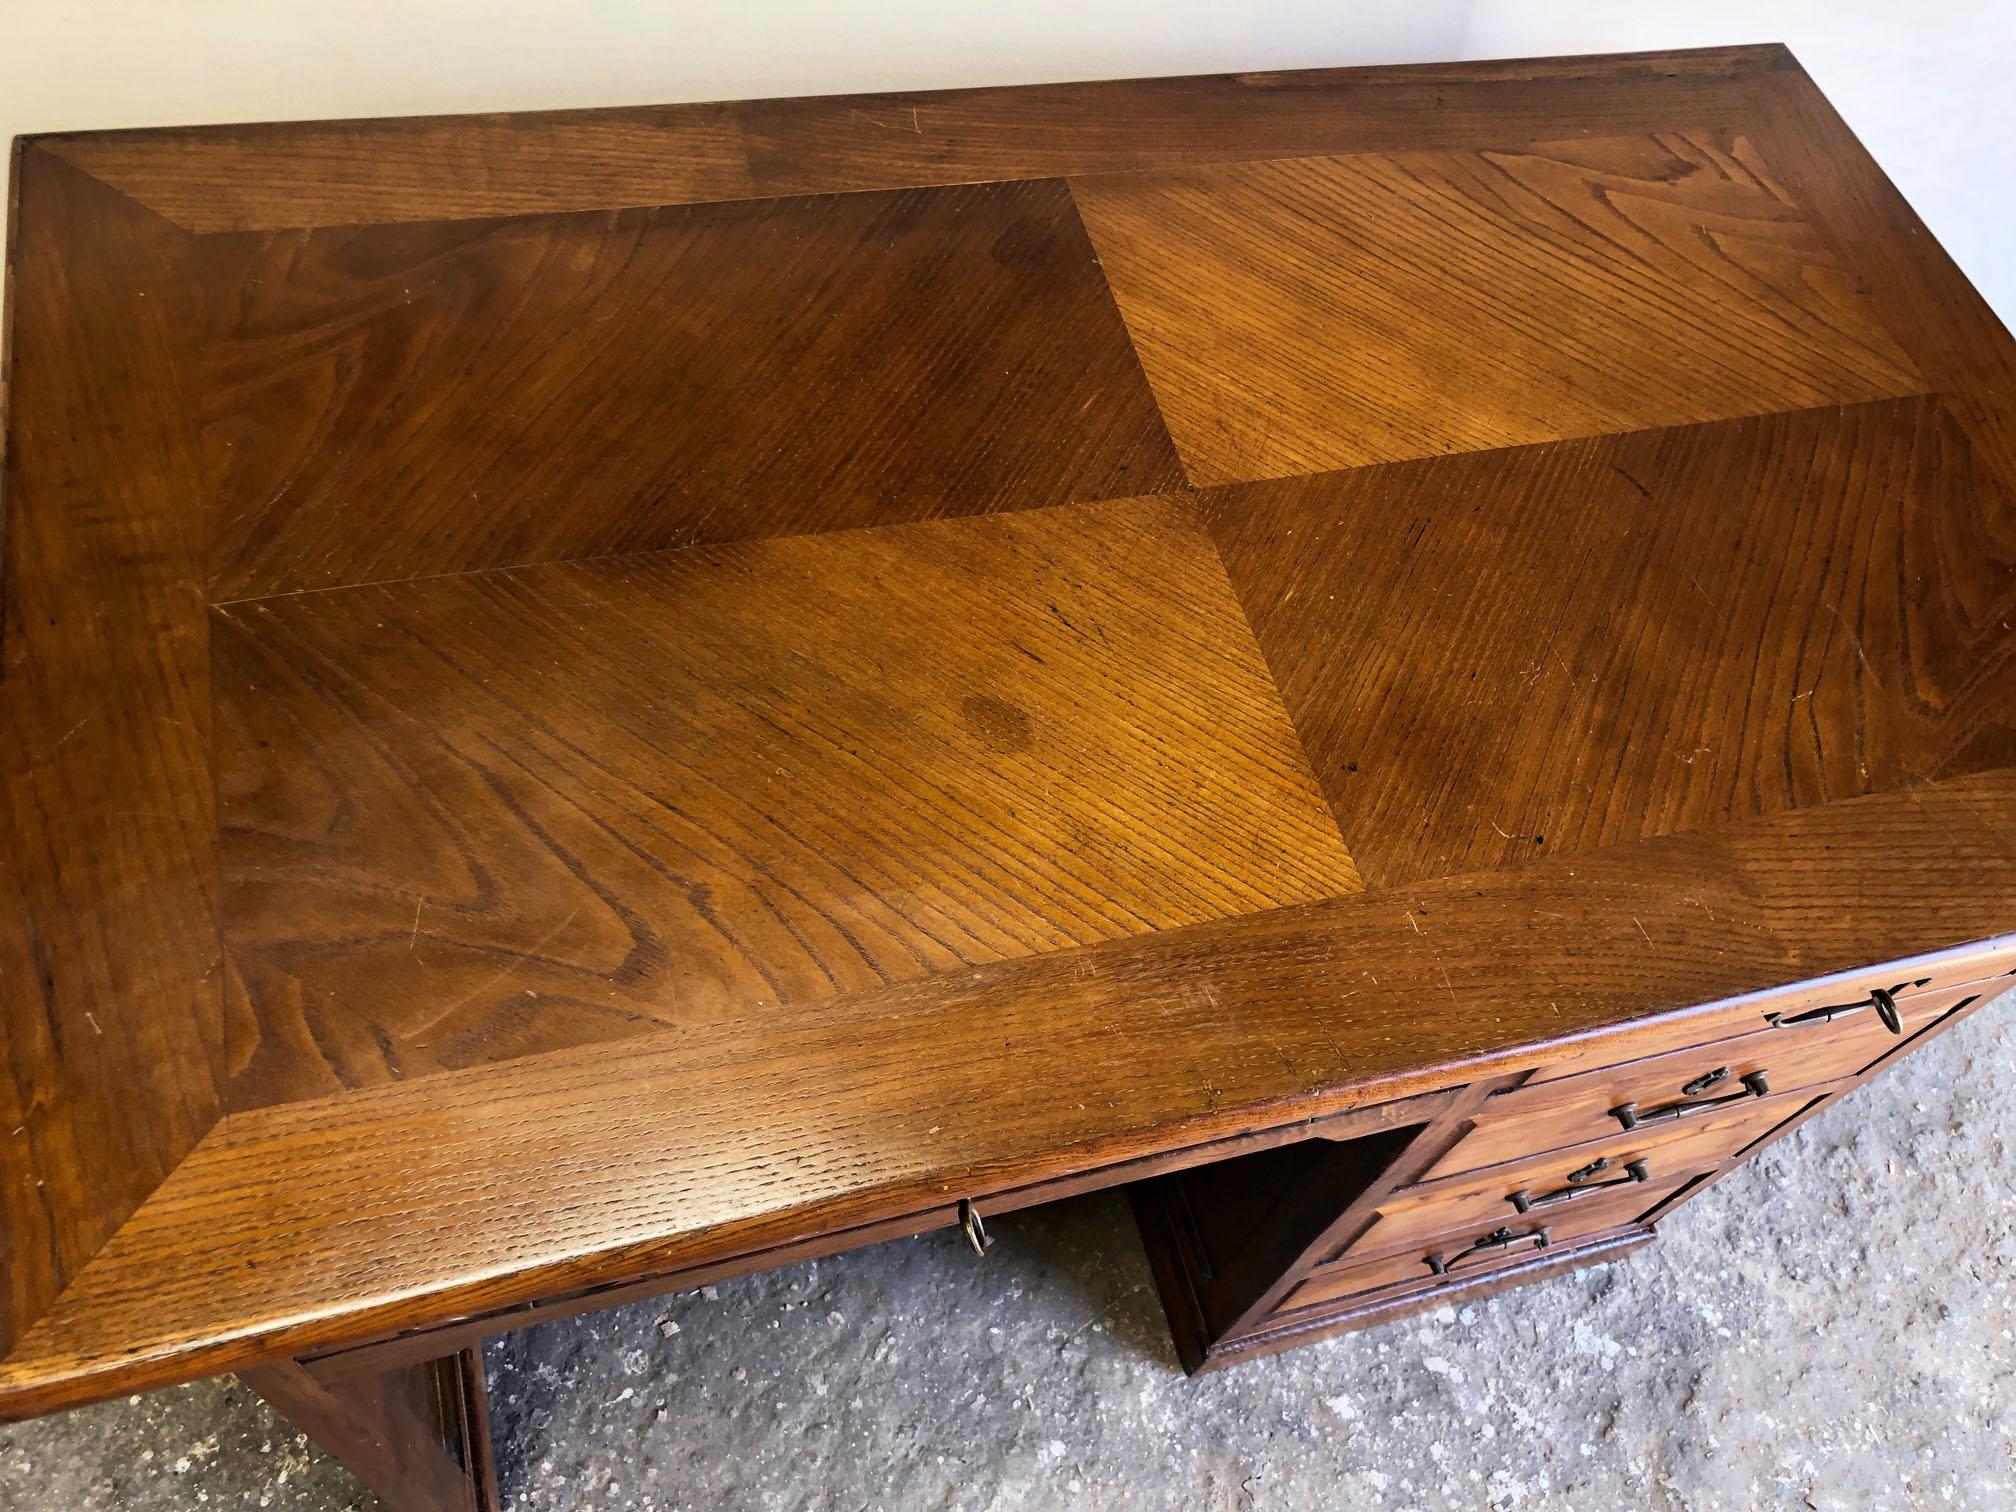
238, 1345, 498, 1512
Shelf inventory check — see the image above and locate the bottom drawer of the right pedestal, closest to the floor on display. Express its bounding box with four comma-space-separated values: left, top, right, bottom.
1278, 1171, 1695, 1312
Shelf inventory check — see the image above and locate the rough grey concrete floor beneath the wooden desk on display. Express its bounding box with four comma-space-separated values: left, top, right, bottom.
0, 998, 2016, 1512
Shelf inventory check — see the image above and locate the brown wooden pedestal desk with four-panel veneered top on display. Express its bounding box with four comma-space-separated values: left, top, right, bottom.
0, 46, 2016, 1508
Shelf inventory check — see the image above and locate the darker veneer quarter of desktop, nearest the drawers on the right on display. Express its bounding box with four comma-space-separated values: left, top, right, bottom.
1210, 399, 2016, 887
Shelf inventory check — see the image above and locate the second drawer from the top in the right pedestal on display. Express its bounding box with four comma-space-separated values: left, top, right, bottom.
1423, 980, 2000, 1179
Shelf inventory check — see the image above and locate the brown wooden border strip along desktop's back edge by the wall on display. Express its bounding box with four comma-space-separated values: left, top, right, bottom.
40, 46, 1790, 232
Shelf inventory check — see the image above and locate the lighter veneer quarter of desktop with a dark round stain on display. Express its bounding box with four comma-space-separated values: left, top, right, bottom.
216, 500, 1359, 1105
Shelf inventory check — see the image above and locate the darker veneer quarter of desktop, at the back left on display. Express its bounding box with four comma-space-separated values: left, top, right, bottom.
204, 183, 1181, 601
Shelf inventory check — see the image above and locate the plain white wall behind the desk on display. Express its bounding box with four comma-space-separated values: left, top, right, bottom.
0, 0, 2016, 325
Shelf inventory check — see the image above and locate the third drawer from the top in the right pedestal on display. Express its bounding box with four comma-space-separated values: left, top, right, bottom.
1331, 1089, 1824, 1260
